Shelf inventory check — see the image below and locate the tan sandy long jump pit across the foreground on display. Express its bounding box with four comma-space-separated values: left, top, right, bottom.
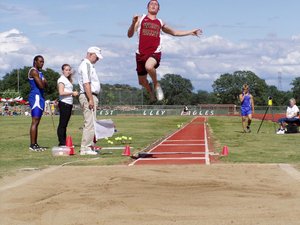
0, 164, 300, 225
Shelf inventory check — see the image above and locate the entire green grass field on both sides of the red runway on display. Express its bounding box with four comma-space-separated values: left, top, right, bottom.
0, 116, 300, 176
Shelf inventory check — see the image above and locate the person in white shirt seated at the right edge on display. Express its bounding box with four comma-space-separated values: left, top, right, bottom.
277, 98, 299, 134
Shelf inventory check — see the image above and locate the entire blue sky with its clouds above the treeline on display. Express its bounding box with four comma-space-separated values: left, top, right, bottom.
0, 0, 300, 91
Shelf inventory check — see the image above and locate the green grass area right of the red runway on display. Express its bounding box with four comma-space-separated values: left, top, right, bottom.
209, 117, 300, 163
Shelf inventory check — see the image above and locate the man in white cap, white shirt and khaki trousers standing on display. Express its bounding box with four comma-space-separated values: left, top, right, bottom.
78, 47, 103, 155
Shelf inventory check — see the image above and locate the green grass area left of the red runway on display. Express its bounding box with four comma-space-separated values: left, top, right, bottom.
0, 115, 191, 177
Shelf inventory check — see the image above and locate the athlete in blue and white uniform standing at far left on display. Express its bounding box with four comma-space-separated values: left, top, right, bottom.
28, 55, 48, 152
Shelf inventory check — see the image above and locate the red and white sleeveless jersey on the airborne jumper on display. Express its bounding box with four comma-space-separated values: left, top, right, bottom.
137, 15, 163, 55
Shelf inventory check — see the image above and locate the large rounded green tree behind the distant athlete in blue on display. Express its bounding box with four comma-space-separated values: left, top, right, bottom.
212, 71, 268, 105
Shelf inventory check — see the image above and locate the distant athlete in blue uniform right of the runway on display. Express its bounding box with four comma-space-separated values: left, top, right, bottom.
240, 84, 254, 133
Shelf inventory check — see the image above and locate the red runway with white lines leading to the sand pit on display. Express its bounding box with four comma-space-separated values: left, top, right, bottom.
130, 117, 214, 165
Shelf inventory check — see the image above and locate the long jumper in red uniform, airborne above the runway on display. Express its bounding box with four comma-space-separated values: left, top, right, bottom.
127, 0, 202, 101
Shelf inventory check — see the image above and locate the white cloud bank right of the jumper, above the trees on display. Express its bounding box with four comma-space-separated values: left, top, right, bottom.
162, 35, 300, 89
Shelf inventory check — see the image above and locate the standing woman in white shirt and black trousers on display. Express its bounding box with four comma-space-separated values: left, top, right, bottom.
57, 64, 78, 146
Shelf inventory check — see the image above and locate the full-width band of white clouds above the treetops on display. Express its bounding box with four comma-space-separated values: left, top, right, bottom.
0, 29, 300, 90
